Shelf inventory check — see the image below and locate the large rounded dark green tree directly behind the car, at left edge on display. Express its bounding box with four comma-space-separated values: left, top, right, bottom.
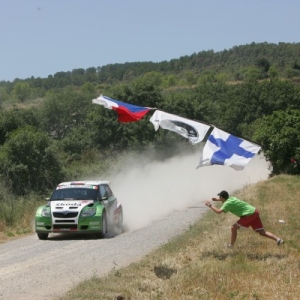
0, 126, 63, 195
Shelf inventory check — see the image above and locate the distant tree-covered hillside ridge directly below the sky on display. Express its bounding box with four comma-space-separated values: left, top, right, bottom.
0, 42, 300, 91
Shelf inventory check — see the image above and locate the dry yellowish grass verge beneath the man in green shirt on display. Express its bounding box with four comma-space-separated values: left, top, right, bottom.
60, 175, 300, 300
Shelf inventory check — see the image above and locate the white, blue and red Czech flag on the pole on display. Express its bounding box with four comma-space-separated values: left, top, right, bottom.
92, 95, 151, 122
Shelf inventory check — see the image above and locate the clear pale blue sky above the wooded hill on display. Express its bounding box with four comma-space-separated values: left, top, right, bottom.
0, 0, 300, 81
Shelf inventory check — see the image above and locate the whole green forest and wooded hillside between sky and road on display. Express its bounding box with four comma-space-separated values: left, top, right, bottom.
0, 43, 300, 197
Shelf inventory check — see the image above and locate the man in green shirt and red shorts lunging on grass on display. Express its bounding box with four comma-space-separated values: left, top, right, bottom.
205, 191, 283, 248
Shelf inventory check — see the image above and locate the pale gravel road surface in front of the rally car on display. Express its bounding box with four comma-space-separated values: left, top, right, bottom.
0, 203, 206, 300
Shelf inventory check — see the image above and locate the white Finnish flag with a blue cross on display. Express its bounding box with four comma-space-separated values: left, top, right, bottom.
197, 127, 261, 171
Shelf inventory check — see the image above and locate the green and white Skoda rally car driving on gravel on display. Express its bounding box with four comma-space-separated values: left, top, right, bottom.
35, 181, 123, 240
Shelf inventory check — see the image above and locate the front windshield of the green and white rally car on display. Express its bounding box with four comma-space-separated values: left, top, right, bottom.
50, 188, 97, 200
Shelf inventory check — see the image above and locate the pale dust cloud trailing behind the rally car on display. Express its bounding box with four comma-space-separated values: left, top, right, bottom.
109, 154, 270, 231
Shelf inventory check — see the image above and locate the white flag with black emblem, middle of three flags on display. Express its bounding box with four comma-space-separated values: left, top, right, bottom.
150, 110, 210, 144
